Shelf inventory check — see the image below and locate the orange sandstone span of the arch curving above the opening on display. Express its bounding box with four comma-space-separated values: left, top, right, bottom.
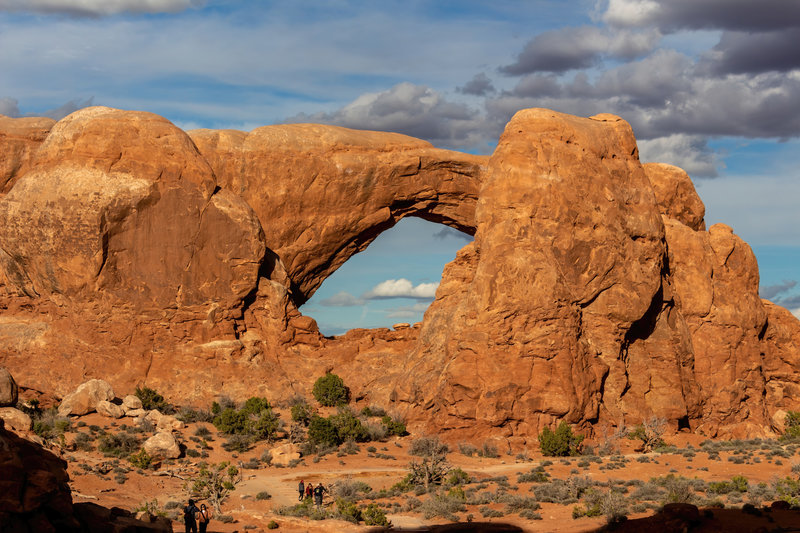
189, 124, 488, 306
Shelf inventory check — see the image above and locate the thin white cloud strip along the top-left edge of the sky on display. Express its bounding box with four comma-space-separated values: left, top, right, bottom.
0, 0, 202, 17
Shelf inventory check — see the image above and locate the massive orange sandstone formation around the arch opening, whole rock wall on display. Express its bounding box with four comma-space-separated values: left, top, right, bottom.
0, 108, 800, 446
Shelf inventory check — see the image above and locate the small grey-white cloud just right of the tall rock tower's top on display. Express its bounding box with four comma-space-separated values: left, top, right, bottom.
638, 133, 722, 178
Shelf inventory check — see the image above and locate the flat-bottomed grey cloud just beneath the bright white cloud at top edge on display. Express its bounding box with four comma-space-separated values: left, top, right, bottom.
500, 26, 660, 75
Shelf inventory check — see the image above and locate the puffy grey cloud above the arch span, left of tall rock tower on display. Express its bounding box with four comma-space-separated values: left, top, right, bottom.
286, 82, 485, 152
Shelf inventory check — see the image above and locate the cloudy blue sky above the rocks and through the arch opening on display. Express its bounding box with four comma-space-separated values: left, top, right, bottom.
0, 0, 800, 334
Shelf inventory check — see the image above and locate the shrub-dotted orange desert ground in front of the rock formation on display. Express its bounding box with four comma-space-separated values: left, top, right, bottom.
21, 386, 800, 533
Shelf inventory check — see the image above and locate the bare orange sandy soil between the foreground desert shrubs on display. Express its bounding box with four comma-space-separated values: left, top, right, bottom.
56, 413, 800, 533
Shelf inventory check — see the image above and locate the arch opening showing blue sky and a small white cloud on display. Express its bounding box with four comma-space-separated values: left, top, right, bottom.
300, 216, 473, 336
